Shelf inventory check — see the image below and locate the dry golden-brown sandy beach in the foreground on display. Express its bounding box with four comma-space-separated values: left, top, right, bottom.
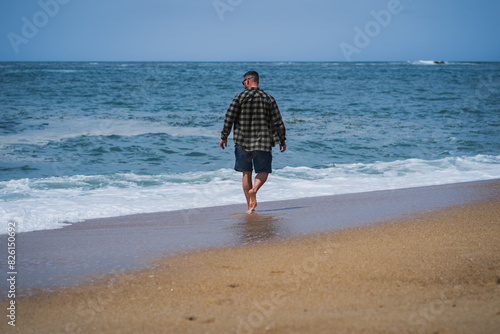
0, 181, 500, 333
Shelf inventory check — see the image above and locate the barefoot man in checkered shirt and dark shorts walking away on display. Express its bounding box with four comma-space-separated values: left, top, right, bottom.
219, 71, 286, 212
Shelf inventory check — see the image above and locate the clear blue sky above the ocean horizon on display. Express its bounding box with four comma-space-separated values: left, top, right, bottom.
0, 0, 500, 61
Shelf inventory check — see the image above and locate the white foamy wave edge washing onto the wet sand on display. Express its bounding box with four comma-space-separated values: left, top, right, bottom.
0, 155, 500, 233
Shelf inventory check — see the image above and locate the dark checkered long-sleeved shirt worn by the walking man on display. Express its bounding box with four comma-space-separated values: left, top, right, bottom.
221, 87, 286, 151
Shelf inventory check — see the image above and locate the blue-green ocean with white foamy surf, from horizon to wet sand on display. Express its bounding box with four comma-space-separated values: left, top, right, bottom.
0, 61, 500, 234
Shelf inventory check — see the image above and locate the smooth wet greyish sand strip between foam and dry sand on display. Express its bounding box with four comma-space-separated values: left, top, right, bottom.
0, 180, 500, 294
